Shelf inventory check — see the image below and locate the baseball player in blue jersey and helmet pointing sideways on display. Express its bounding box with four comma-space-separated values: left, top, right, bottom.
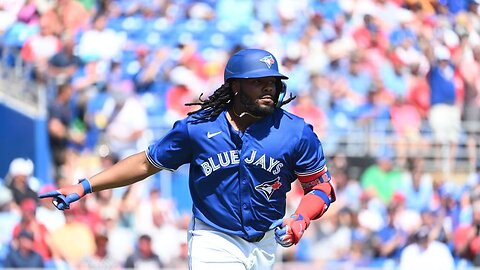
40, 49, 335, 270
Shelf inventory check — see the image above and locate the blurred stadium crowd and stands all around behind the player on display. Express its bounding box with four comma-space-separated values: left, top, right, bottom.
0, 0, 480, 269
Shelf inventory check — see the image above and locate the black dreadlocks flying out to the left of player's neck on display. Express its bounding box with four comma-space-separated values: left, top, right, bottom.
185, 82, 233, 122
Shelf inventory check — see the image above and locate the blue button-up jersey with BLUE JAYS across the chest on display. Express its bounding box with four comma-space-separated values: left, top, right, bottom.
146, 109, 325, 238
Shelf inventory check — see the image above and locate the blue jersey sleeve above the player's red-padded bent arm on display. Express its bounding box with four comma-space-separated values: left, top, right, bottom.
295, 124, 326, 177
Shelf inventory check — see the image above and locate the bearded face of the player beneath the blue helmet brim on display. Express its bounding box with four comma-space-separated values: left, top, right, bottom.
239, 77, 277, 116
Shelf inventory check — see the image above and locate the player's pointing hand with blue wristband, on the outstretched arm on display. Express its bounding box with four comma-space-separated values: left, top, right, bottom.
38, 179, 92, 210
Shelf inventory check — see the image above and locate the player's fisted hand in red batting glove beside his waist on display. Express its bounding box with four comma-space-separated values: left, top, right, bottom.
270, 214, 310, 247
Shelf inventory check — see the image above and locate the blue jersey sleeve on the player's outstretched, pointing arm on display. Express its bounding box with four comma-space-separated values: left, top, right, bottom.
146, 119, 192, 171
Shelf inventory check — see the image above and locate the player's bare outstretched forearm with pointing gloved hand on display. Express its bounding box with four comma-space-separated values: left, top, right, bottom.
38, 152, 160, 210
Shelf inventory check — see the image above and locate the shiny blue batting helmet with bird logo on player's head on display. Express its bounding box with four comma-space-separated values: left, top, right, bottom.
224, 49, 288, 81
